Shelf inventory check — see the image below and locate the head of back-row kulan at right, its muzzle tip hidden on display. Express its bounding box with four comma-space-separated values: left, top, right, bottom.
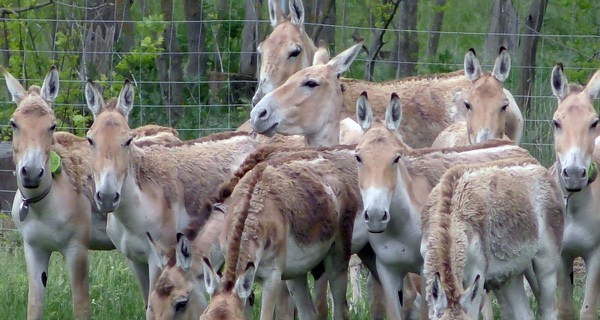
464, 47, 510, 144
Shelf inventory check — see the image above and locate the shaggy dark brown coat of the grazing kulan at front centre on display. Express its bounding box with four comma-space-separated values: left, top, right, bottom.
218, 148, 360, 287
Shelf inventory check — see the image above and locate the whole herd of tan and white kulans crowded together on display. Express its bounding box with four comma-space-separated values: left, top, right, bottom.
1, 0, 600, 320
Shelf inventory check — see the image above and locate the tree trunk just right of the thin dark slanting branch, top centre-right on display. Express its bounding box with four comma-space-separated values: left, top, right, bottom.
393, 0, 419, 78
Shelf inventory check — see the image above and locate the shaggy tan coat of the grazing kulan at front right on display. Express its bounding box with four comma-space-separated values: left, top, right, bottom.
421, 157, 563, 315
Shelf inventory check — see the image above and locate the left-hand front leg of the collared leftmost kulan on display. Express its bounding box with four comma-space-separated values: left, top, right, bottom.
23, 243, 51, 320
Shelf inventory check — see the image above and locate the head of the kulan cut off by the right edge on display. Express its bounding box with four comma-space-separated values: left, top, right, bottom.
550, 64, 600, 191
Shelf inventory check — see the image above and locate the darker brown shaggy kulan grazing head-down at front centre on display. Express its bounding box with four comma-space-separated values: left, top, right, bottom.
201, 149, 360, 319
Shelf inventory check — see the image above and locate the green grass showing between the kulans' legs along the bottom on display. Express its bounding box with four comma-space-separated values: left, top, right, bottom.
0, 232, 584, 320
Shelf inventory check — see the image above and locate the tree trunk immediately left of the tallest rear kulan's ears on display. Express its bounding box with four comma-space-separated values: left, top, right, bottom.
240, 0, 261, 75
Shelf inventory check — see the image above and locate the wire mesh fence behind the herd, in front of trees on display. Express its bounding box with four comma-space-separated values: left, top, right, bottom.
0, 0, 600, 220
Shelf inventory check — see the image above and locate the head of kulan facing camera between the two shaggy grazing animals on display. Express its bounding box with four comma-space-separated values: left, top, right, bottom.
355, 92, 407, 233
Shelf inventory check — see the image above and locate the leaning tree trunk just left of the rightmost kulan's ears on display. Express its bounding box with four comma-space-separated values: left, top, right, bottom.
516, 0, 548, 118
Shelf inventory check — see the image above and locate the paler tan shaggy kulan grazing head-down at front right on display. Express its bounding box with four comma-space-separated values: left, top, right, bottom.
421, 157, 564, 319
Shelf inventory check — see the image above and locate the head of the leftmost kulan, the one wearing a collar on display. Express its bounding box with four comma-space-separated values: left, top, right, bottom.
0, 66, 59, 189
